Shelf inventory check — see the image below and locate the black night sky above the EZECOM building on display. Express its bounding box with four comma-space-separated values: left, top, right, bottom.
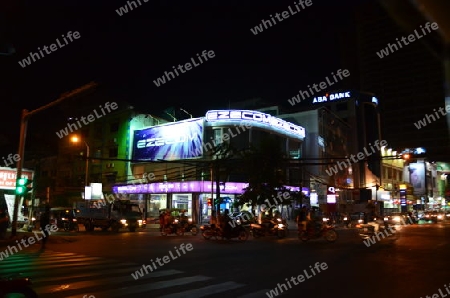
0, 0, 370, 156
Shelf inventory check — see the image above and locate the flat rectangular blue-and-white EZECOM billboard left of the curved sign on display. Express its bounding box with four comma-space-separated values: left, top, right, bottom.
133, 118, 203, 161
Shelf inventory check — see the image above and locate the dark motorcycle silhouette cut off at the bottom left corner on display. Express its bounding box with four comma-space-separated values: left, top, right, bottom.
0, 275, 38, 298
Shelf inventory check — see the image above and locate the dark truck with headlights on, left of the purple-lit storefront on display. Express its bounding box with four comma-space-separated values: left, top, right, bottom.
77, 200, 146, 232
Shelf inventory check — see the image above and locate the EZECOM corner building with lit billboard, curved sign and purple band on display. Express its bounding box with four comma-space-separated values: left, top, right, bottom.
113, 110, 305, 221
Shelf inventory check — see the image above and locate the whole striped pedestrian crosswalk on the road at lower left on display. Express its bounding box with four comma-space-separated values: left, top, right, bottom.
0, 252, 269, 298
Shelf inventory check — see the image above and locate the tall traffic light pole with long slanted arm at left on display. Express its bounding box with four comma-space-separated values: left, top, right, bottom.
11, 82, 97, 236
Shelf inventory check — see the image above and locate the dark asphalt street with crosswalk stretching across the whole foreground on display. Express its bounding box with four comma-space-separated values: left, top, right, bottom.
0, 223, 450, 298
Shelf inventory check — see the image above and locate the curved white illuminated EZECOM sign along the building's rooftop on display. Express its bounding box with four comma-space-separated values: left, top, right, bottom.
206, 110, 305, 138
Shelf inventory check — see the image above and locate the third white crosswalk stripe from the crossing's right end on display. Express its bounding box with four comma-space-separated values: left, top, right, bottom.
73, 275, 212, 298
